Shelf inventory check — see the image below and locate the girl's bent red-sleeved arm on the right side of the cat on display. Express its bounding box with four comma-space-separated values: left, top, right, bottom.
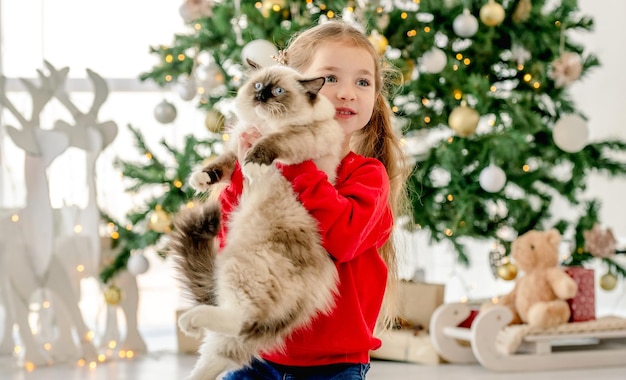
281, 158, 393, 262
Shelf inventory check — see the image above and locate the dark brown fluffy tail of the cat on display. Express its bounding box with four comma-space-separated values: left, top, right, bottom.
168, 202, 221, 305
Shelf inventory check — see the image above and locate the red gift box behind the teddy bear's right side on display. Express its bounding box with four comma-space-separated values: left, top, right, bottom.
564, 267, 596, 322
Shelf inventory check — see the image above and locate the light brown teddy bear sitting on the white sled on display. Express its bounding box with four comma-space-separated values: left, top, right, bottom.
498, 229, 578, 328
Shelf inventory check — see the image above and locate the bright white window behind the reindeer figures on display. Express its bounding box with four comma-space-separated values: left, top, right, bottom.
0, 0, 206, 349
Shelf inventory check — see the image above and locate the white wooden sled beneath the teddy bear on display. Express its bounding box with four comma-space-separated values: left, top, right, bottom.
430, 303, 626, 372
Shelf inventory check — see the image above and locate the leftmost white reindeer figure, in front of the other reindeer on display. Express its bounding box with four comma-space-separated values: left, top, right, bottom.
0, 64, 97, 367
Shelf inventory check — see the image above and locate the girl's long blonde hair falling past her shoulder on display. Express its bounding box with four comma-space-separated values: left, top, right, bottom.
283, 21, 410, 326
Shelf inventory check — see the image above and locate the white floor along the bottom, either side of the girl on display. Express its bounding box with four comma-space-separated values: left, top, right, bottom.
0, 352, 626, 380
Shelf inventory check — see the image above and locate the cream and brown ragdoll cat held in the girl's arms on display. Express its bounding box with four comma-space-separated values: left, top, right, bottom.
170, 60, 344, 380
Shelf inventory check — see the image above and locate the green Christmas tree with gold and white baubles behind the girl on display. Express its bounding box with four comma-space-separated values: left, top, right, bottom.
101, 0, 626, 284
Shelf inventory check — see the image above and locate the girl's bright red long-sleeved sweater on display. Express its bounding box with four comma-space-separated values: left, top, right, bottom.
220, 153, 393, 366
